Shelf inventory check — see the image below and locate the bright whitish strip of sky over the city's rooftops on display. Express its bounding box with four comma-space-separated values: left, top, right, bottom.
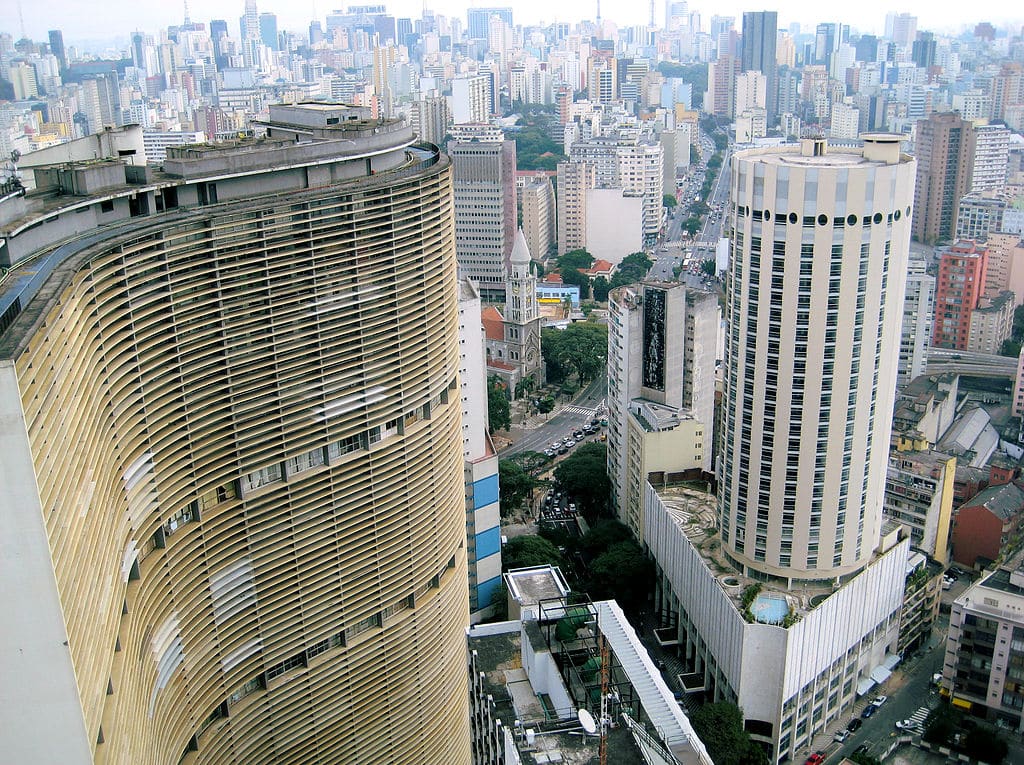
14, 0, 1024, 44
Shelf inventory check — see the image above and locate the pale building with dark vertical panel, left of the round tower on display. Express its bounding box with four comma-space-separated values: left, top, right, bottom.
607, 282, 719, 539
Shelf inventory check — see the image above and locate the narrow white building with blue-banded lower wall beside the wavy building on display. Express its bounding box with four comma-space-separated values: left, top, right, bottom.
459, 279, 502, 623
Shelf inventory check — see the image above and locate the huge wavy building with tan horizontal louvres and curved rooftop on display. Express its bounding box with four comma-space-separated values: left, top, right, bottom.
0, 104, 470, 765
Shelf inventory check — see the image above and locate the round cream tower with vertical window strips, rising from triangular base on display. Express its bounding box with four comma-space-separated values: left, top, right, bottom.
719, 134, 914, 581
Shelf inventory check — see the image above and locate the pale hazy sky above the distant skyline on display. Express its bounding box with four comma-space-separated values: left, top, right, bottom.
14, 0, 1024, 44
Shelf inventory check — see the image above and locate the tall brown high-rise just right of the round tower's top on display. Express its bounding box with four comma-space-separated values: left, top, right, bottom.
913, 112, 975, 245
